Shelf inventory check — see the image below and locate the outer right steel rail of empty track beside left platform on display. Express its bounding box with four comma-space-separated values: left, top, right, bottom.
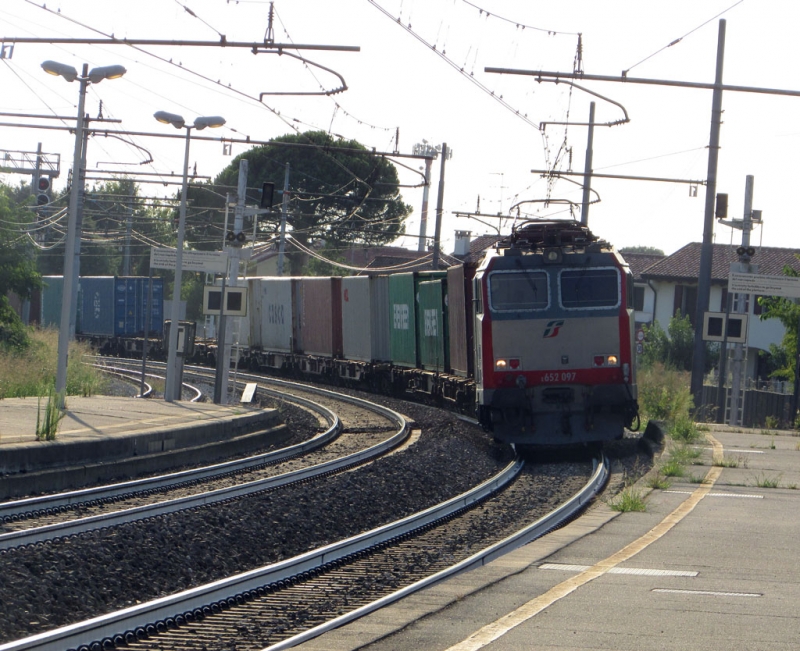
0, 382, 411, 550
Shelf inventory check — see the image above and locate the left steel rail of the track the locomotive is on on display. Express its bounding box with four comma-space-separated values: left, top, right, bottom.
0, 459, 524, 651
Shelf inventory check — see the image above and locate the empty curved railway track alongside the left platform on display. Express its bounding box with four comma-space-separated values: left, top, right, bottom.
0, 372, 410, 550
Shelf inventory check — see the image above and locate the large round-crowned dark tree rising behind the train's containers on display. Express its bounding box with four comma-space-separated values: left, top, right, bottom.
186, 131, 411, 275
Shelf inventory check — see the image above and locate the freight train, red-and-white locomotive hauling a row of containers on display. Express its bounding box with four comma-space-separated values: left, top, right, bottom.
31, 220, 639, 446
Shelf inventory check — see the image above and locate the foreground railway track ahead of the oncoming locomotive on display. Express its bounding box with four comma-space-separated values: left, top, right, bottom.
0, 459, 608, 651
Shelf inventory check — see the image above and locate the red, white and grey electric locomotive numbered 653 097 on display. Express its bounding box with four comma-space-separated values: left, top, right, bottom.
473, 220, 638, 445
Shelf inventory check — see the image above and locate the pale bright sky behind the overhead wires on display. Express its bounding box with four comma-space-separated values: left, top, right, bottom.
0, 0, 800, 262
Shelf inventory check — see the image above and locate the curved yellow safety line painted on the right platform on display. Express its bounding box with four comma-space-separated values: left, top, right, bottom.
447, 434, 723, 651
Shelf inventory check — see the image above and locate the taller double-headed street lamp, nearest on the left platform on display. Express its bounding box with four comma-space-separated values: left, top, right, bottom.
42, 61, 126, 409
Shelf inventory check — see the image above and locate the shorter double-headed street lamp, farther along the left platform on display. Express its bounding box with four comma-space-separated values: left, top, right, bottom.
153, 111, 225, 402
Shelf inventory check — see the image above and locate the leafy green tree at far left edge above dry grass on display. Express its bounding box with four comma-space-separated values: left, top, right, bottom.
0, 185, 41, 349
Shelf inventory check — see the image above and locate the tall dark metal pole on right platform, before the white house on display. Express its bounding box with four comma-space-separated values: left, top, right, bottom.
691, 20, 725, 409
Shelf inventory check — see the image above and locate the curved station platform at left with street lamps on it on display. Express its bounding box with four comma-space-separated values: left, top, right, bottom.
0, 396, 290, 499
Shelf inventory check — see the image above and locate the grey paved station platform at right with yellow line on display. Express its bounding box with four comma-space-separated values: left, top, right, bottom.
295, 428, 800, 651
